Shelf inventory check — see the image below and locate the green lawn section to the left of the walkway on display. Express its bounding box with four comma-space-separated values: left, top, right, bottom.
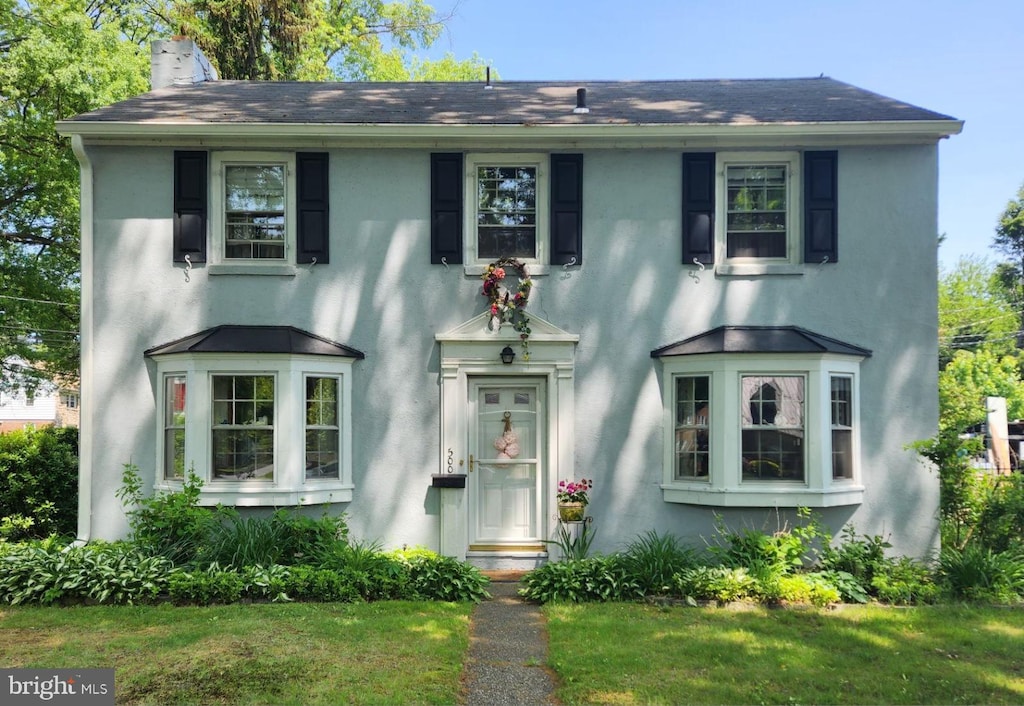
0, 601, 472, 705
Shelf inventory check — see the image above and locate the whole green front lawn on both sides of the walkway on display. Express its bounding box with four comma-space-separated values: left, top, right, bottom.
0, 601, 1024, 705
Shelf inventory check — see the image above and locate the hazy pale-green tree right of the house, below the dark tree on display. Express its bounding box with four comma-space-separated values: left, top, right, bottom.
939, 256, 1018, 369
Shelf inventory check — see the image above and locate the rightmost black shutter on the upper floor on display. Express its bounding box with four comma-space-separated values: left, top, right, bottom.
804, 150, 839, 262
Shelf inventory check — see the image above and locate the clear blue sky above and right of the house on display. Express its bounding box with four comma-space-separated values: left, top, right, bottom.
430, 0, 1024, 266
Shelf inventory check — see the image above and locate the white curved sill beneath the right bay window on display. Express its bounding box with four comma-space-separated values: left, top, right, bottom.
662, 484, 864, 507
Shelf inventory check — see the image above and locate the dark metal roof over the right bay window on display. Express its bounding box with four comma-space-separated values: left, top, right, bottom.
650, 326, 871, 358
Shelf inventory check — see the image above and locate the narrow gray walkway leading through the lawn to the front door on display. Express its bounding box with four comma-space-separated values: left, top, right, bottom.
462, 577, 558, 706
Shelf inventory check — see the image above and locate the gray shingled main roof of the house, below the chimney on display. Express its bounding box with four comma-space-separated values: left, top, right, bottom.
69, 78, 955, 125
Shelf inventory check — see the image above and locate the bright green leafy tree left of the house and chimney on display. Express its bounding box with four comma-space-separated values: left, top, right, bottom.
0, 0, 147, 385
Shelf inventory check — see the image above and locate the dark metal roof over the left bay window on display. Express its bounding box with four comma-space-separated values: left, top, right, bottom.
145, 326, 366, 360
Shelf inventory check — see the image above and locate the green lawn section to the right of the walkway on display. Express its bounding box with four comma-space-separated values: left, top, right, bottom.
543, 604, 1024, 705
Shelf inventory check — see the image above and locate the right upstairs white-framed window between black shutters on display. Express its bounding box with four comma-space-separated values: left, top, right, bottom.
715, 152, 803, 266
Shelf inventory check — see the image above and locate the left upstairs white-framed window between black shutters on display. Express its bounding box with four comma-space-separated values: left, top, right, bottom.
210, 152, 296, 266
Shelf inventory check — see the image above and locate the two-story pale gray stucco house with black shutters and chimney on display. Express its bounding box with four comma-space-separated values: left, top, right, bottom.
59, 40, 962, 567
